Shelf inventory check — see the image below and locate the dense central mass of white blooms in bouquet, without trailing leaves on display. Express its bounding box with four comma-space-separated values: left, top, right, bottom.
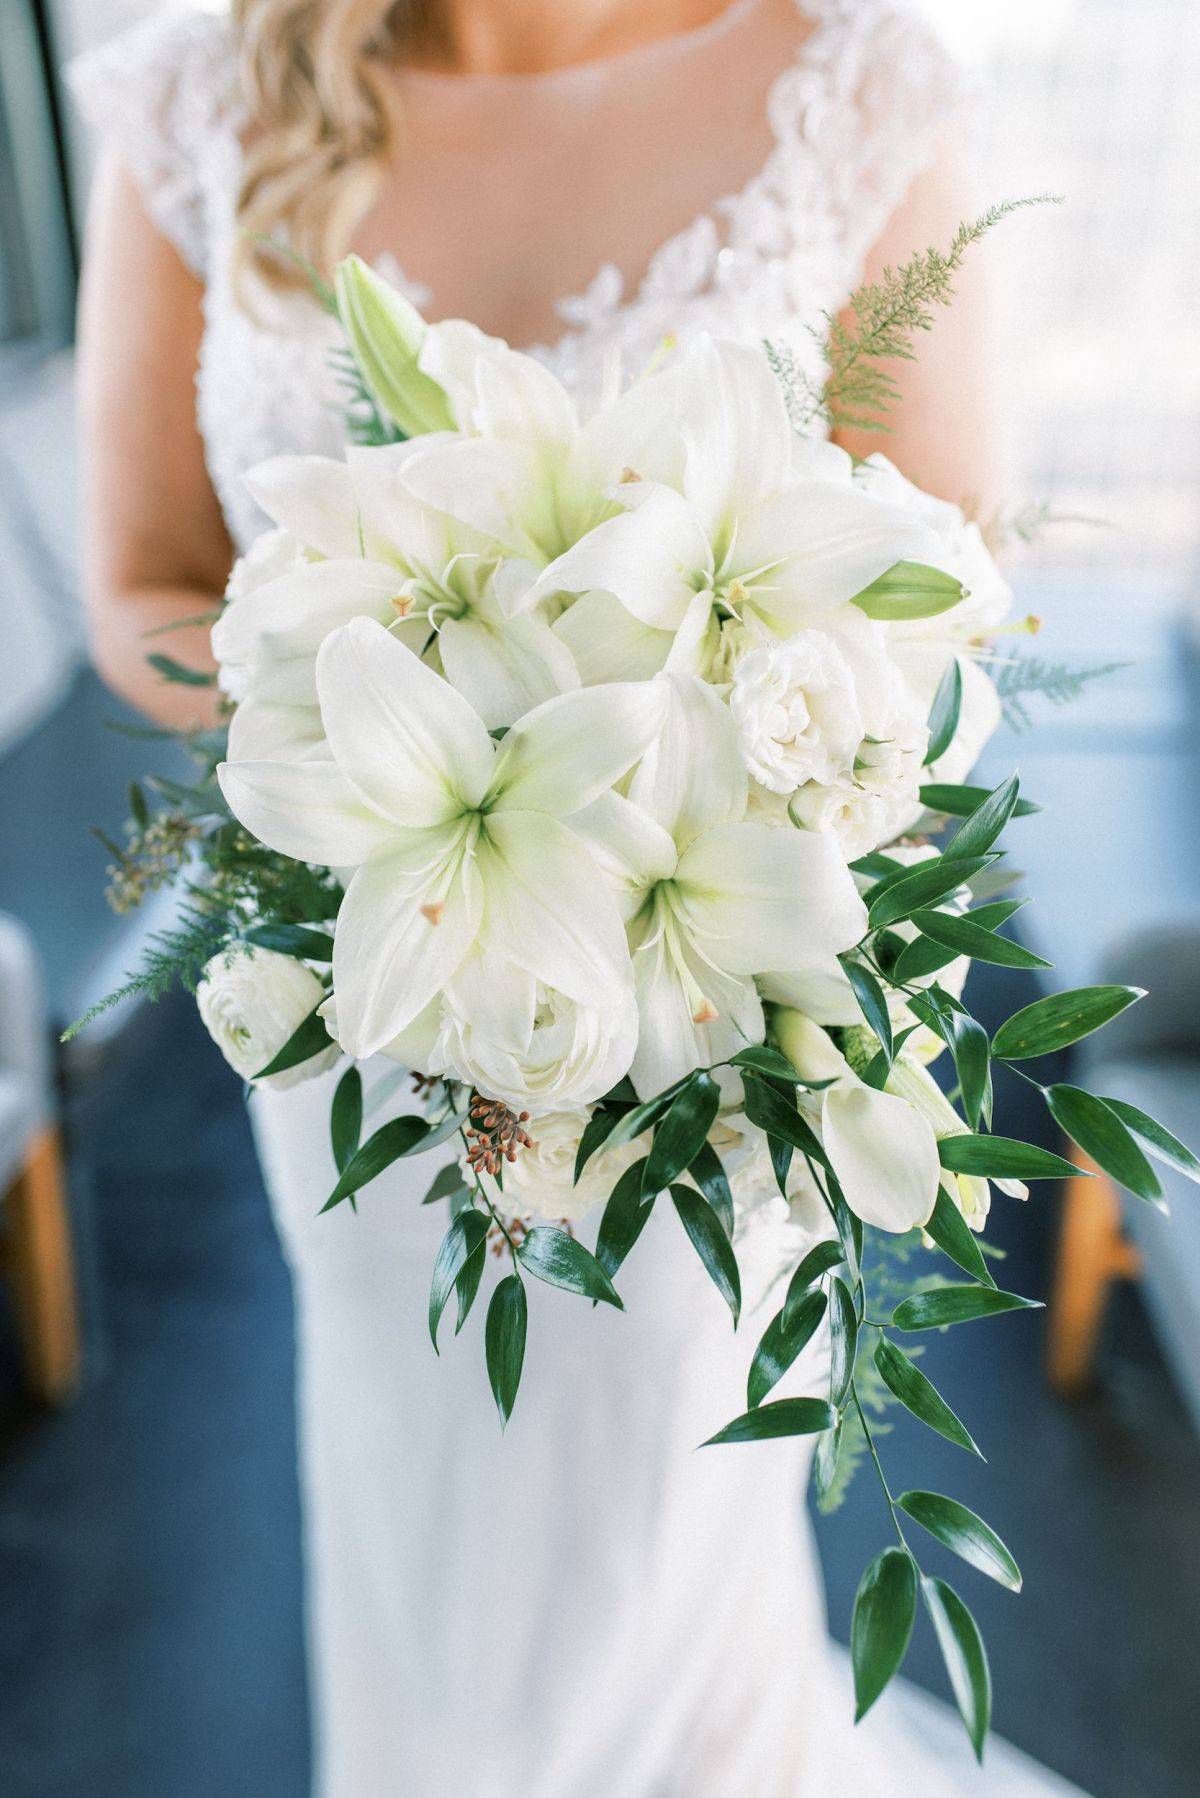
209, 264, 1007, 1237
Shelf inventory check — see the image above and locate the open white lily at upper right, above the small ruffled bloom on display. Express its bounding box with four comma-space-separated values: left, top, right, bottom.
536, 338, 941, 680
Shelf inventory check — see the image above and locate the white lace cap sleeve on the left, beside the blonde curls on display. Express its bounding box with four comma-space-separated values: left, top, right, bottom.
67, 11, 241, 275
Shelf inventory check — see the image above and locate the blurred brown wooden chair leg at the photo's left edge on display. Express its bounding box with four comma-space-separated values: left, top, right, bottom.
0, 1129, 79, 1404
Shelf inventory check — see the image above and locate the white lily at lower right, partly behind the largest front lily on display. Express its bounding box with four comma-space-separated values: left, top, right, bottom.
578, 676, 865, 1095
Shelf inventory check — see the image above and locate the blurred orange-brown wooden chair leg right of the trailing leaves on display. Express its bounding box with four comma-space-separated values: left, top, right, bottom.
1047, 1151, 1141, 1397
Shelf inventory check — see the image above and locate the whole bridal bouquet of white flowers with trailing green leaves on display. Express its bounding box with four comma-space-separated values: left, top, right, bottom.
79, 224, 1200, 1749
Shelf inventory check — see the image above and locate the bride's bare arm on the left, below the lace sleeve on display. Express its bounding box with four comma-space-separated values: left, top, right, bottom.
79, 162, 234, 728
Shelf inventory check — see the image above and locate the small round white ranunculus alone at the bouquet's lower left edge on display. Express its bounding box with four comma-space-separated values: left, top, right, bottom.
196, 949, 340, 1091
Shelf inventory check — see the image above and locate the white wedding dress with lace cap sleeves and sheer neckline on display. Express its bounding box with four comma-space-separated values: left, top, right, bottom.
74, 0, 1086, 1798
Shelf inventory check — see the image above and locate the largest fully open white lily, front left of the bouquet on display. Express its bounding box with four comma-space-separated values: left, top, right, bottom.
218, 619, 662, 1057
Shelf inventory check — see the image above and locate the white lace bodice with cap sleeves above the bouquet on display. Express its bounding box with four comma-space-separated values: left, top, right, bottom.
70, 0, 961, 548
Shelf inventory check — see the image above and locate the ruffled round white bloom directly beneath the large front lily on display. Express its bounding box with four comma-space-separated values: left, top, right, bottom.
428, 982, 637, 1118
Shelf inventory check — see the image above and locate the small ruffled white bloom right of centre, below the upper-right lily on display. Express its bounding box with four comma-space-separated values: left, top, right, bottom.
729, 631, 864, 793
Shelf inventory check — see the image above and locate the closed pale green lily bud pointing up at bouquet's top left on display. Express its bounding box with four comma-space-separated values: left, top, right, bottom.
333, 255, 453, 437
